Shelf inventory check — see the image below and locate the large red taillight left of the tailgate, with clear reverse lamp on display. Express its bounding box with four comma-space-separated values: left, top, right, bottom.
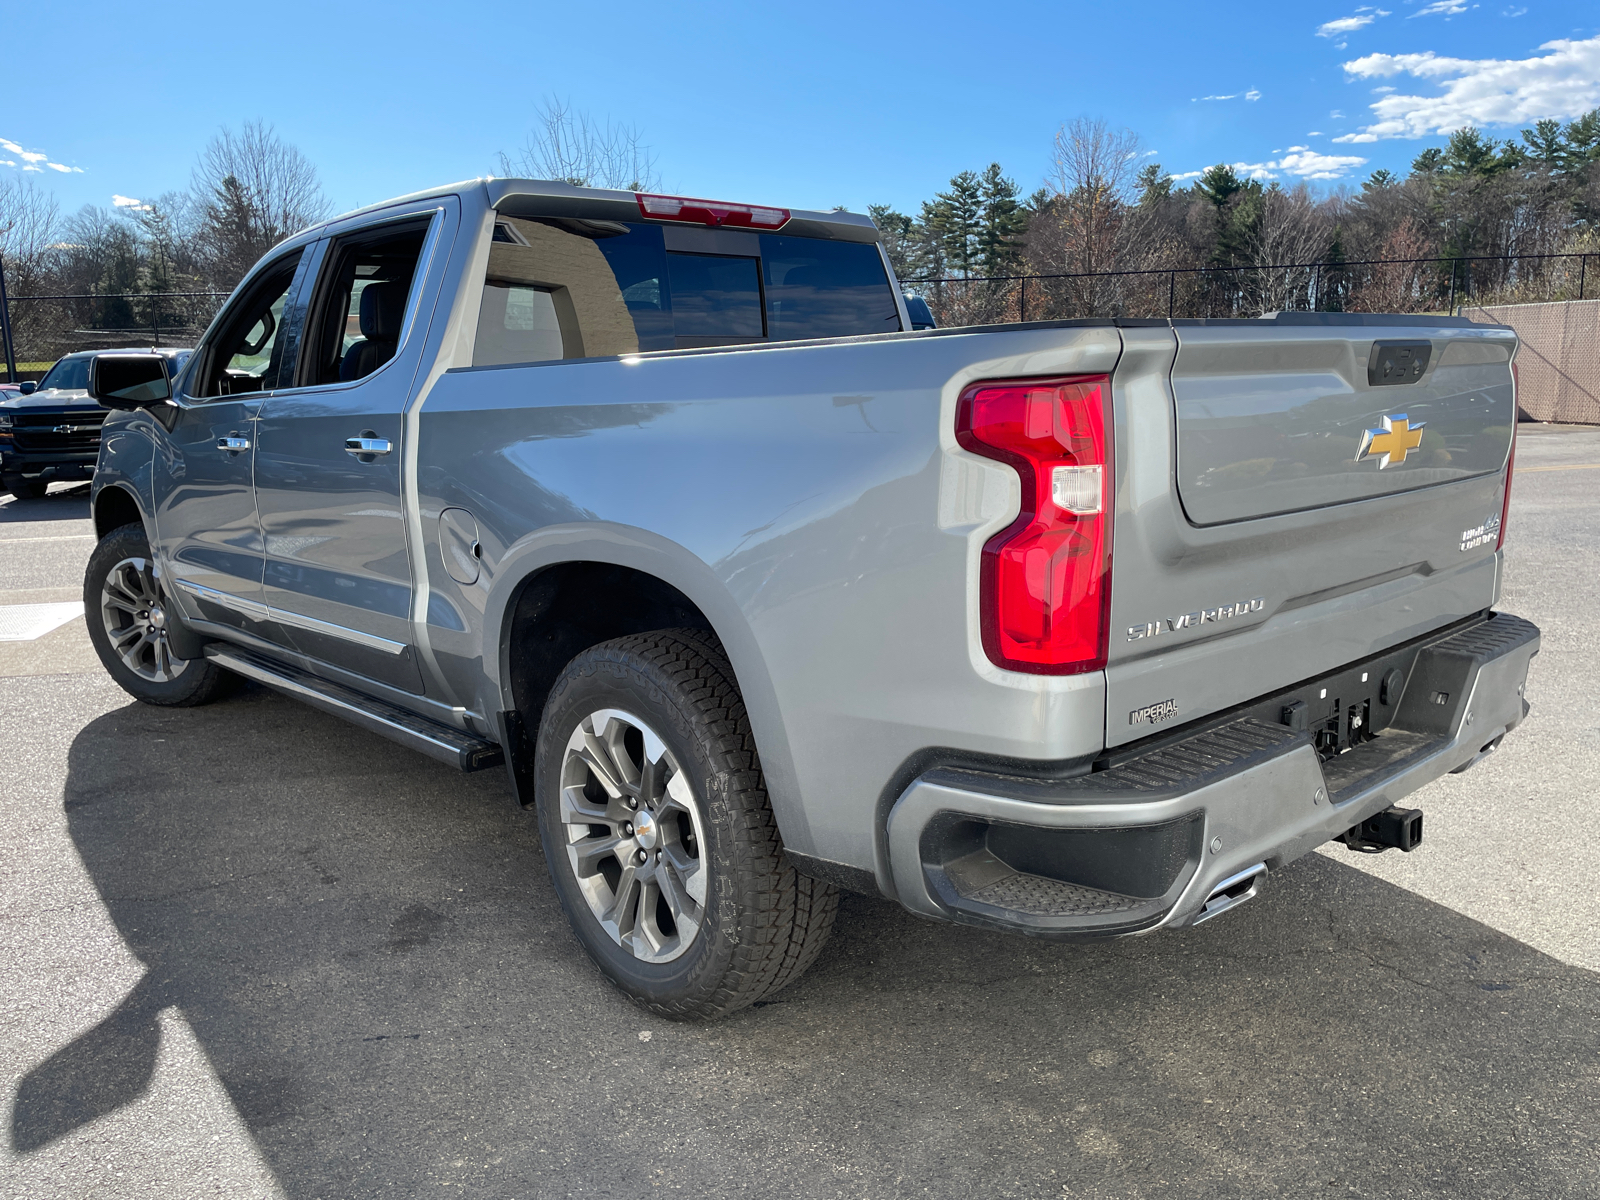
955, 374, 1112, 675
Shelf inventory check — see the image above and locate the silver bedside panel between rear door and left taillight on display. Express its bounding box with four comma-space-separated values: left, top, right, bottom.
419, 328, 1120, 886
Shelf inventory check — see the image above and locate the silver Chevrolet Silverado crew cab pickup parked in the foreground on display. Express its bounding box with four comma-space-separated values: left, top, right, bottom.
85, 179, 1539, 1018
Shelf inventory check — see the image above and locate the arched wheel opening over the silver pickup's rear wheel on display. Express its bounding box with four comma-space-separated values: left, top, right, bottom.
483, 526, 811, 853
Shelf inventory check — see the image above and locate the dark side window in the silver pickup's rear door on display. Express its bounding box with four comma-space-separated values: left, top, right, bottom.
299, 219, 427, 386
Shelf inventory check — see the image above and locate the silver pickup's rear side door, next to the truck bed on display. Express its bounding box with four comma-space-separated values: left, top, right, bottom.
256, 202, 454, 693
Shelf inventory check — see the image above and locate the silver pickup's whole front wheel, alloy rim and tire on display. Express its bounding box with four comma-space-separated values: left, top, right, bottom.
83, 525, 235, 707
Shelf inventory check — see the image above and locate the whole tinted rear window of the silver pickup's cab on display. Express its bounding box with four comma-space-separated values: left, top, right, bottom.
472, 218, 901, 366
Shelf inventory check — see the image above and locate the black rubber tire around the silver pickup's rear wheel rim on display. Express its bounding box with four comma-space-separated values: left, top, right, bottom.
534, 629, 838, 1021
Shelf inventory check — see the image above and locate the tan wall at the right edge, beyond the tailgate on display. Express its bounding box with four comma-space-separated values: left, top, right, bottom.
1461, 301, 1600, 426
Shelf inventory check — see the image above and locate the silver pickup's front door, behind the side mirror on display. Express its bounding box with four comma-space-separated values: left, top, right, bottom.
152, 250, 307, 637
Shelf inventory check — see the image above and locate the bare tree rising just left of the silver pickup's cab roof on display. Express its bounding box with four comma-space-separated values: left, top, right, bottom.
190, 122, 330, 286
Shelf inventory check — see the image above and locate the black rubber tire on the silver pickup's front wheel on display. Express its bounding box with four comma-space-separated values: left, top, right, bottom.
83, 523, 238, 709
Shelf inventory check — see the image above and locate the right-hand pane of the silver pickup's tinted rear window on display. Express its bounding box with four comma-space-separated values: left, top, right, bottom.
762, 234, 899, 341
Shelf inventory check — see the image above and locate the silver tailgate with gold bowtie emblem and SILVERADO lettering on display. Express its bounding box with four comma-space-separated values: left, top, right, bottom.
1106, 317, 1517, 746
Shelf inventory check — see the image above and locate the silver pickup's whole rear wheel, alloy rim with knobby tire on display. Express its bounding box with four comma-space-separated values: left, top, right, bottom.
534, 629, 838, 1019
